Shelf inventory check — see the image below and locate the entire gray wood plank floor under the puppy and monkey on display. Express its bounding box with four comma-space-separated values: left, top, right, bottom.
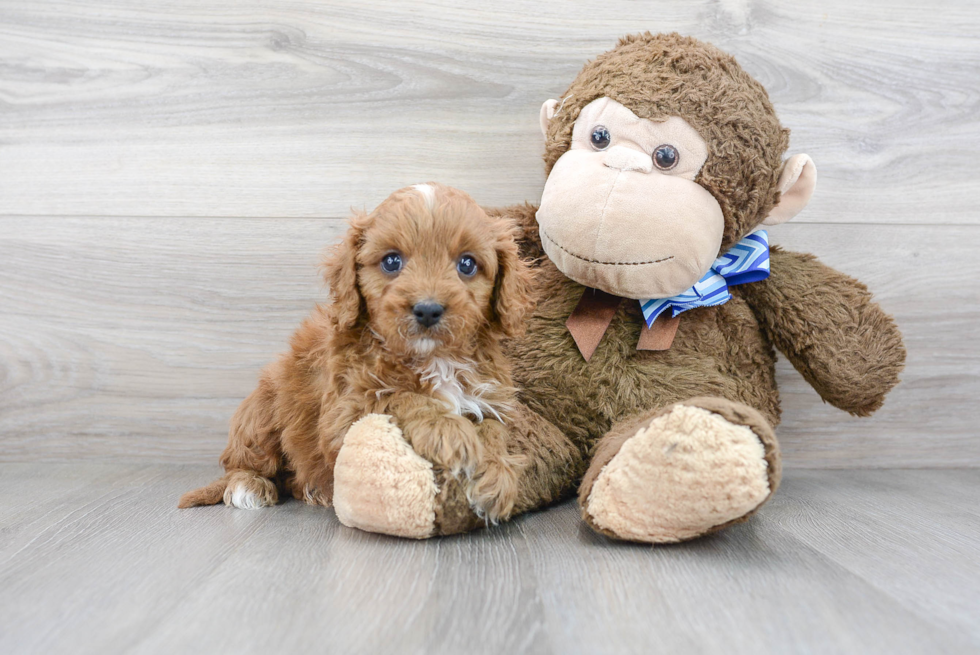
0, 464, 980, 654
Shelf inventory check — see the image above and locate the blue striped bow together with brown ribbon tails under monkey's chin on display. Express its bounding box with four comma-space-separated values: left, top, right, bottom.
565, 230, 769, 361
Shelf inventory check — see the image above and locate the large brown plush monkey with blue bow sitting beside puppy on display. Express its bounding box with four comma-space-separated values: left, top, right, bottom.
341, 33, 905, 543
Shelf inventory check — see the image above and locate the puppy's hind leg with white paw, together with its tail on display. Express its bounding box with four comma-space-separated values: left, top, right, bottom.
177, 375, 283, 509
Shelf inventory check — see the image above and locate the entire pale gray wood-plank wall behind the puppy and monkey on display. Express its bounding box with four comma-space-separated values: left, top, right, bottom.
0, 0, 980, 467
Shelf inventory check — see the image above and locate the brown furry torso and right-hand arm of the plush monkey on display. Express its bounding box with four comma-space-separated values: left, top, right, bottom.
491, 205, 905, 453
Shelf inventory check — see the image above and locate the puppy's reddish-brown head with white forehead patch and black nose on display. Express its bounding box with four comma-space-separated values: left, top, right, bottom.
325, 184, 530, 357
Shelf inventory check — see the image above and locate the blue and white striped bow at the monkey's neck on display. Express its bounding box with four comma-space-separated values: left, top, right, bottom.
640, 230, 769, 327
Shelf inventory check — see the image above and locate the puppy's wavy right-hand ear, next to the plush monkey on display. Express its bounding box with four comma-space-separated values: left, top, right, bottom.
492, 219, 534, 337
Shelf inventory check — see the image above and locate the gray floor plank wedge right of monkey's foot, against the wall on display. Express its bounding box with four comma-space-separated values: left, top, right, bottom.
765, 470, 980, 643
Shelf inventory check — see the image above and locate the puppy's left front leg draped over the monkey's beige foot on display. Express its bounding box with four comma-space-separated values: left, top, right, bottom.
387, 393, 483, 477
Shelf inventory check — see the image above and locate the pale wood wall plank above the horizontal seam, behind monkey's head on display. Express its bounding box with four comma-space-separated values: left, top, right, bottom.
0, 0, 980, 224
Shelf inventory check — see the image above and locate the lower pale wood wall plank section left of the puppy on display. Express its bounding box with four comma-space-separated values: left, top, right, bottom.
0, 218, 343, 462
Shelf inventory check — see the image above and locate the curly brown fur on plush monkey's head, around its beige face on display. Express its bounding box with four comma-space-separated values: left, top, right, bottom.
544, 33, 789, 251
